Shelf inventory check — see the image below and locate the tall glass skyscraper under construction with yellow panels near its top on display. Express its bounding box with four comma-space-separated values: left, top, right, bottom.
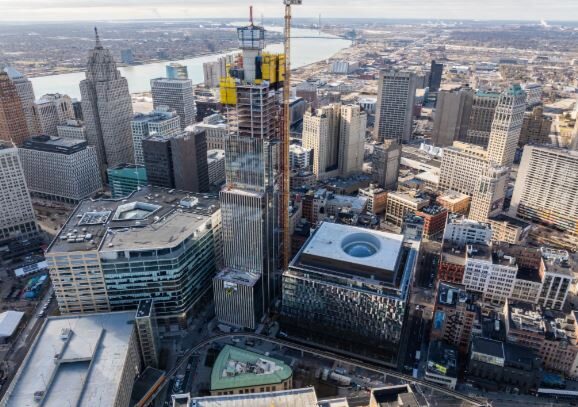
213, 15, 284, 328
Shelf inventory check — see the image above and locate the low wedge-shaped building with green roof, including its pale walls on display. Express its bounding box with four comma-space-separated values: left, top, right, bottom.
211, 345, 293, 396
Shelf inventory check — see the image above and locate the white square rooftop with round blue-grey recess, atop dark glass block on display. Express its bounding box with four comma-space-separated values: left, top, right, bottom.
303, 222, 403, 271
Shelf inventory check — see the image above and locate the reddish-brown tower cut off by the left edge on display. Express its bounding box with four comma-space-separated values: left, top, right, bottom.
0, 70, 30, 146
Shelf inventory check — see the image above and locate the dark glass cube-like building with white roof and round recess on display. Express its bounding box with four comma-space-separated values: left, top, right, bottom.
281, 222, 419, 366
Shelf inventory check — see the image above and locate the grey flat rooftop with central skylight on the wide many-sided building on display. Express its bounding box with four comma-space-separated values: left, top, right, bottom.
47, 186, 219, 253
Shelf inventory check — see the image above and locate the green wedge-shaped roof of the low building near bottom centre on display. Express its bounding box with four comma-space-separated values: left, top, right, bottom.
211, 345, 293, 391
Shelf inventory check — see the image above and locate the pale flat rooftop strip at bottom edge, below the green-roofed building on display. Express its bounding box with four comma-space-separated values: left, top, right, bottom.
193, 387, 317, 407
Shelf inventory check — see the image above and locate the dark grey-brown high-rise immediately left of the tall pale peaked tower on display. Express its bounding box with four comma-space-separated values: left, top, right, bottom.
460, 91, 500, 148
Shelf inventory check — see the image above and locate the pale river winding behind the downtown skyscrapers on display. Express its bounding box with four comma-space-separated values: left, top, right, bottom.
30, 27, 351, 99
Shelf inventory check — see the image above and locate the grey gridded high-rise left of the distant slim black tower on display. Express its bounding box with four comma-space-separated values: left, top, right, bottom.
373, 70, 417, 144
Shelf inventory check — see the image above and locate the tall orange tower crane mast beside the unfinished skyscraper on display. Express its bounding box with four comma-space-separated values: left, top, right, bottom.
280, 0, 302, 270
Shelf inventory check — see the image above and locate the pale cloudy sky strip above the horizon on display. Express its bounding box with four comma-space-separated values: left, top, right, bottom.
0, 0, 578, 21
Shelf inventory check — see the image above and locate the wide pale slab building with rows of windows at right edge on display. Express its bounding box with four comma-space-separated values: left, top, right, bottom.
510, 146, 578, 236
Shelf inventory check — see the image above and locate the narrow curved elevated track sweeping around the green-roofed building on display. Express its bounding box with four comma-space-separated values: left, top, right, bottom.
135, 332, 490, 407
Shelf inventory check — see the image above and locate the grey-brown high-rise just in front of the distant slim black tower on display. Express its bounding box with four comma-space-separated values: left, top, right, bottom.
432, 87, 474, 147
